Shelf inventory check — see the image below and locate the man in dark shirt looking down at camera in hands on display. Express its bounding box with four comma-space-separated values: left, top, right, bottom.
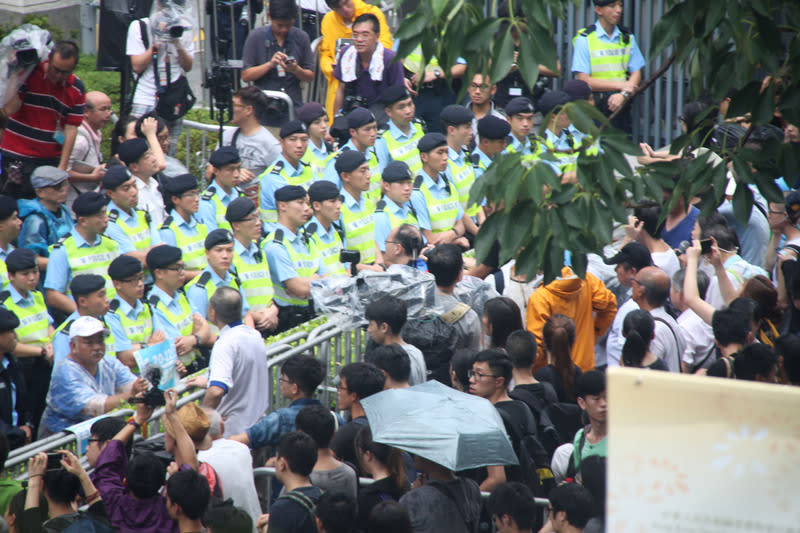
242, 0, 314, 135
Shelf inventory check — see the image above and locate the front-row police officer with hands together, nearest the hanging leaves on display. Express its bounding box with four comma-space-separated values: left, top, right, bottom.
411, 133, 469, 248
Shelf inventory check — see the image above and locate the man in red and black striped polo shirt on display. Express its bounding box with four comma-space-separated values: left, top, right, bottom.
0, 41, 86, 198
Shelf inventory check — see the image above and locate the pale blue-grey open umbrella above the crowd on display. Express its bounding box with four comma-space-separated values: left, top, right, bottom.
361, 381, 519, 471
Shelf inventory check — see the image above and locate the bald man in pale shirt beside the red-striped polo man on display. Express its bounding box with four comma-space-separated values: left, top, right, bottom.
67, 91, 111, 205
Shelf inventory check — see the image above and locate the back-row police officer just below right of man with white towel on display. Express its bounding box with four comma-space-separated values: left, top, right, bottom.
375, 85, 425, 175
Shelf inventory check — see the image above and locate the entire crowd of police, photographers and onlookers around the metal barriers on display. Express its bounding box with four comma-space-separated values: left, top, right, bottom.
0, 0, 800, 533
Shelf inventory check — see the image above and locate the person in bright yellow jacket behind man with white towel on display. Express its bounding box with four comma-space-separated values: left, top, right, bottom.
319, 0, 392, 122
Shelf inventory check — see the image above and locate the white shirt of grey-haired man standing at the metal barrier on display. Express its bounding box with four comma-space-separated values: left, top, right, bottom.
208, 324, 269, 437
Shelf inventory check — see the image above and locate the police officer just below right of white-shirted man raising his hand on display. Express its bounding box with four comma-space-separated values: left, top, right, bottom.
159, 174, 208, 280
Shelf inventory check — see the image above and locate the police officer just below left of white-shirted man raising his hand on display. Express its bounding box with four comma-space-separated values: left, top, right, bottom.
103, 165, 161, 261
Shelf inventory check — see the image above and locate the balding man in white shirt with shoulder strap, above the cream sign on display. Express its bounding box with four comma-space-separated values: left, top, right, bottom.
631, 266, 686, 372
